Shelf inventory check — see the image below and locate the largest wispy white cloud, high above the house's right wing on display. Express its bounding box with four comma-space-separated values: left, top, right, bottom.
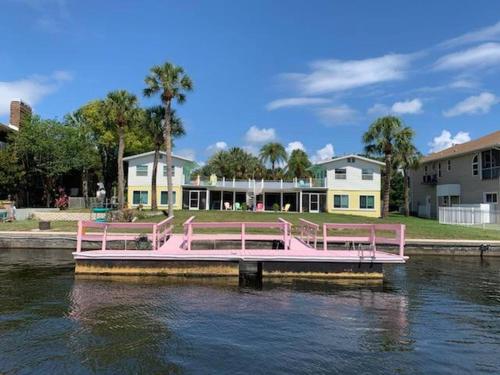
283, 54, 411, 95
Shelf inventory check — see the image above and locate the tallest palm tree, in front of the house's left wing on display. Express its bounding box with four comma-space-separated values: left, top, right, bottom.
144, 62, 193, 217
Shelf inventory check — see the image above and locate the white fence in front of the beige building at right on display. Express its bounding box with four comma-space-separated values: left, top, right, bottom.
439, 206, 500, 226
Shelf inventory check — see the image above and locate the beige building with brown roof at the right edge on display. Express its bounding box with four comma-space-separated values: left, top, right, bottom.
410, 131, 500, 218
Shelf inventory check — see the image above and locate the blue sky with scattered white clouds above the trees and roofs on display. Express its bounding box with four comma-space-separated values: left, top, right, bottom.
0, 0, 500, 161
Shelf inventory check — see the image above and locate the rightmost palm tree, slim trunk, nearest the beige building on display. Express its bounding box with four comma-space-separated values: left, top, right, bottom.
395, 127, 422, 216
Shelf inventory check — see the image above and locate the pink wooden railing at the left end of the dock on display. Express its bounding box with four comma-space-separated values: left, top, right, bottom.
76, 216, 174, 252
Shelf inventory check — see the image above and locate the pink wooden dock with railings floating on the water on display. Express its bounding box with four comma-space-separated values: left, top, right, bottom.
73, 216, 407, 278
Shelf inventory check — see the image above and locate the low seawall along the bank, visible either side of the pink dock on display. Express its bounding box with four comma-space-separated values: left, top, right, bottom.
0, 231, 500, 257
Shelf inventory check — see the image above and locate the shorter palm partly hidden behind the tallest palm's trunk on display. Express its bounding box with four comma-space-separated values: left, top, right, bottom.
144, 105, 186, 210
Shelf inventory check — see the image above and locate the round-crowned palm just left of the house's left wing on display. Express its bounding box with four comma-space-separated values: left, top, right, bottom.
105, 90, 138, 208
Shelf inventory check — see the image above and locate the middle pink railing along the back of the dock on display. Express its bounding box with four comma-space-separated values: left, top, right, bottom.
183, 216, 292, 250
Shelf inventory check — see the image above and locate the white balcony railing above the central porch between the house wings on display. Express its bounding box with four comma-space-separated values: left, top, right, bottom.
185, 176, 326, 190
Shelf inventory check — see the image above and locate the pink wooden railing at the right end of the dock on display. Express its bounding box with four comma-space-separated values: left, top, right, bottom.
323, 223, 406, 257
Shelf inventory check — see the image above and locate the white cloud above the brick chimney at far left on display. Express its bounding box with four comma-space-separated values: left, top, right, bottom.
0, 71, 72, 116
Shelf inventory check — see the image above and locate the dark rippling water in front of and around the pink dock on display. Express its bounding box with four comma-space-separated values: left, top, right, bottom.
0, 250, 500, 374
